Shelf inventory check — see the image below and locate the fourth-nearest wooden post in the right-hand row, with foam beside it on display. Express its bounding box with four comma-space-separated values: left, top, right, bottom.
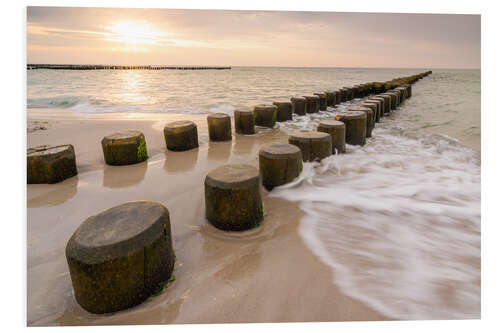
288, 131, 332, 162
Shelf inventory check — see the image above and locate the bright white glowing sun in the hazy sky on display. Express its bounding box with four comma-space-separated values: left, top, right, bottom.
108, 21, 163, 45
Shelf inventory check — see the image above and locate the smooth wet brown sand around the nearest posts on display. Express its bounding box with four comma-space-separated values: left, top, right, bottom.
27, 109, 390, 326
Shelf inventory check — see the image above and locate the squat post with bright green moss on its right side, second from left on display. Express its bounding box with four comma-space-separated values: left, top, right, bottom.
101, 131, 148, 165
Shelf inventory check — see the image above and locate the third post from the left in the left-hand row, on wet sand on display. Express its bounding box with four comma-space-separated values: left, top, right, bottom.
163, 120, 198, 151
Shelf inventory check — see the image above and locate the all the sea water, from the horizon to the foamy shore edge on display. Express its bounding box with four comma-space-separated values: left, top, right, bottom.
27, 67, 481, 319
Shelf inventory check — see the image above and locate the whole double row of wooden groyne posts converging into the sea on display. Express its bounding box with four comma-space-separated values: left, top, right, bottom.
28, 71, 432, 313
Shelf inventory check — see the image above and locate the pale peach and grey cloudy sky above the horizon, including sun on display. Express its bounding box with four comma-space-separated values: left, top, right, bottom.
26, 7, 481, 69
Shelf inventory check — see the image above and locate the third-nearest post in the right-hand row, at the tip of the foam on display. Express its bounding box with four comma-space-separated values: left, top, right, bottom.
259, 143, 302, 191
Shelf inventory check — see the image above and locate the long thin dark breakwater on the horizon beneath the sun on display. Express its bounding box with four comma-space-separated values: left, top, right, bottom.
27, 64, 231, 71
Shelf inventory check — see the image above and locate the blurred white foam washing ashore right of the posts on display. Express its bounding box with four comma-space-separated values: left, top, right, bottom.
271, 122, 481, 319
